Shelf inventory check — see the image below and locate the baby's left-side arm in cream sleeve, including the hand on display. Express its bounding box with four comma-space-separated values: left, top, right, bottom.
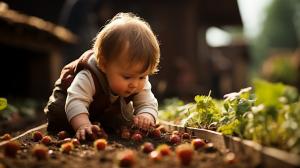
65, 70, 100, 140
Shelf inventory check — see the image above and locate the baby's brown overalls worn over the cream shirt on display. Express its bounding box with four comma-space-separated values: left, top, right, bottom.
44, 50, 133, 133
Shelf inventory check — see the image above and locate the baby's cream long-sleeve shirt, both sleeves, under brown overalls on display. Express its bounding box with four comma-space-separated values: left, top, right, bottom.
65, 69, 158, 121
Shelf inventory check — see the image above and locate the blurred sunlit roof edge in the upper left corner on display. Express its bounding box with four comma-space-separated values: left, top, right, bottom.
0, 2, 77, 49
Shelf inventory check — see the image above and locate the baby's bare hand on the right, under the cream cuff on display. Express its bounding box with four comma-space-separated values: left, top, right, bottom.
133, 113, 155, 130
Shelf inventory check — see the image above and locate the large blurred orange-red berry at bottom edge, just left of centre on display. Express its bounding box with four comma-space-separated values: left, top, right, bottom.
117, 149, 136, 167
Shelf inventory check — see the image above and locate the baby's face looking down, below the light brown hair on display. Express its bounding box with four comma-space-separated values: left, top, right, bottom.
104, 57, 149, 97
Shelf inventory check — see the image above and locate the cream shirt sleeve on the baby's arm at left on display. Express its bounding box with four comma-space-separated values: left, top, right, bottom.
65, 70, 96, 121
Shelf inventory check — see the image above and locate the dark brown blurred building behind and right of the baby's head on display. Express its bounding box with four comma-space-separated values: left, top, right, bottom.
104, 0, 250, 100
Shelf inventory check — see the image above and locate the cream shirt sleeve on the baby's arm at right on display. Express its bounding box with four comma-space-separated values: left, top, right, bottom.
133, 78, 158, 121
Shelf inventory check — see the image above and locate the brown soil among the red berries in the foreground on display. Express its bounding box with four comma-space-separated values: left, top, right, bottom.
0, 126, 258, 168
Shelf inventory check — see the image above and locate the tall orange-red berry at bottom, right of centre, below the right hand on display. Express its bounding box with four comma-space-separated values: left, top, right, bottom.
176, 144, 194, 165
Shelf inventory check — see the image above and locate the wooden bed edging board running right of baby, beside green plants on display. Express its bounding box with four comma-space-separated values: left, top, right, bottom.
161, 121, 300, 168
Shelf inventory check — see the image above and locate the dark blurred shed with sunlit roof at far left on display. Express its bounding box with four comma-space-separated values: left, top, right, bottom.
0, 2, 76, 99
